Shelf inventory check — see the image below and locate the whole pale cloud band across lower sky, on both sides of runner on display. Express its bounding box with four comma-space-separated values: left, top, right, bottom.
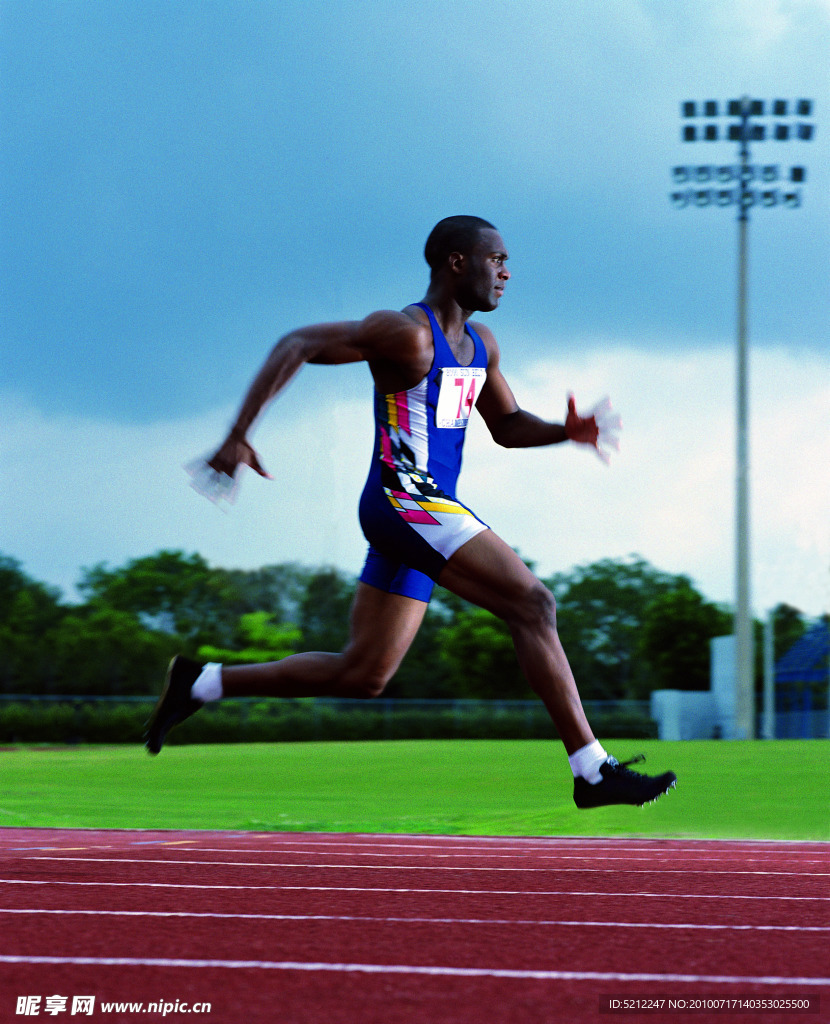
0, 344, 830, 614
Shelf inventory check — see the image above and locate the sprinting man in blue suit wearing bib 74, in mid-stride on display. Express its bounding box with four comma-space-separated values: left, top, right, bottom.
146, 217, 676, 808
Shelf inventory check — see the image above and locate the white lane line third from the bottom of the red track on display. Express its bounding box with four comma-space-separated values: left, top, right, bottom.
0, 879, 830, 903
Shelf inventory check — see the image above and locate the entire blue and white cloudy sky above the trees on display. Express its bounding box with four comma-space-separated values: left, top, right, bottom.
0, 0, 830, 615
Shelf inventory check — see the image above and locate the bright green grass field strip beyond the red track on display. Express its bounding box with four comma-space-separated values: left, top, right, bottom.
0, 740, 830, 840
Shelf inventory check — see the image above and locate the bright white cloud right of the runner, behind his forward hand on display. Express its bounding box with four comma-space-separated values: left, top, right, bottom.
464, 349, 830, 613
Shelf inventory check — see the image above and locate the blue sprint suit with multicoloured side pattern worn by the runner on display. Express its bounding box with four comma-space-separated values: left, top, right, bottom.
360, 303, 488, 600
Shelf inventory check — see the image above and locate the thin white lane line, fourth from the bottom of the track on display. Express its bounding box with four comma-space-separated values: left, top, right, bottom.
28, 856, 830, 879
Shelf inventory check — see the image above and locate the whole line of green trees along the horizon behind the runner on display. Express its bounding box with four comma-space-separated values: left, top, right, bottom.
0, 551, 807, 700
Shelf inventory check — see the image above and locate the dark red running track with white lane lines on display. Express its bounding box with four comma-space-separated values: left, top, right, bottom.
0, 828, 830, 1024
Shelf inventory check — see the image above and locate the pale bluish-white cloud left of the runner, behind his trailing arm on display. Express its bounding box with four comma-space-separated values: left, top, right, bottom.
0, 370, 372, 596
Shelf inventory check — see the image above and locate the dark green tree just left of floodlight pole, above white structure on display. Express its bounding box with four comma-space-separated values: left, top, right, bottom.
640, 586, 732, 690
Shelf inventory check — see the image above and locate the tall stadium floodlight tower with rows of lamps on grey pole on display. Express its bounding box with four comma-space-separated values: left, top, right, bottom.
671, 96, 815, 739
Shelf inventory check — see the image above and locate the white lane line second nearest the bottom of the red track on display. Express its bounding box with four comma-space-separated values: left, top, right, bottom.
0, 907, 830, 932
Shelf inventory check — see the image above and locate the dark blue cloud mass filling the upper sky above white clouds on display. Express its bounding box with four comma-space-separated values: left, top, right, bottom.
0, 0, 830, 420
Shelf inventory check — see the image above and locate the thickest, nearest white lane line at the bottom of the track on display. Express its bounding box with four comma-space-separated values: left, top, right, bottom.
0, 955, 830, 986
